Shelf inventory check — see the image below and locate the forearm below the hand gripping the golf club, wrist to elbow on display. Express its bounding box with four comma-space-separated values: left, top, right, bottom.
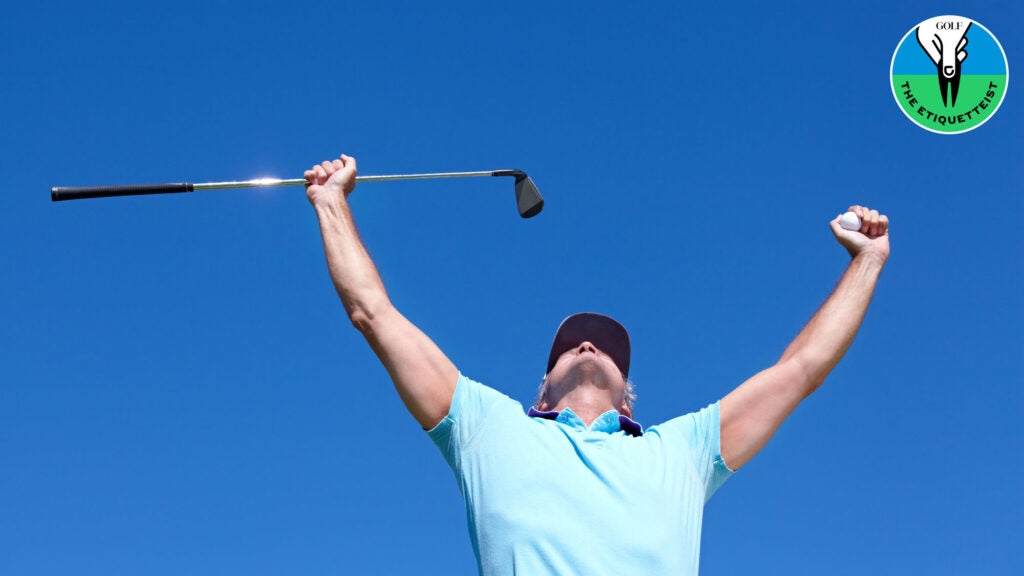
316, 200, 391, 331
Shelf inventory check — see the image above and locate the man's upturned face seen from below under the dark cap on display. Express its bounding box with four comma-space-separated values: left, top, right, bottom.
541, 341, 632, 416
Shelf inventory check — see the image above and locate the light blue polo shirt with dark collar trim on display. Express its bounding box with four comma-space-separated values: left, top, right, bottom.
428, 374, 732, 576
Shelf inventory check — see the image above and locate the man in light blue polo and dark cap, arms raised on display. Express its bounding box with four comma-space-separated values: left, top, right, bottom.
305, 150, 889, 576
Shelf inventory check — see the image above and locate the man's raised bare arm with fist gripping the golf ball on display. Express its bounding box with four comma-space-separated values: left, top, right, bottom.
719, 206, 889, 469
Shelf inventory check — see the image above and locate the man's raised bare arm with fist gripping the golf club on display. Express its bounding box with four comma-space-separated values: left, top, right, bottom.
305, 155, 459, 429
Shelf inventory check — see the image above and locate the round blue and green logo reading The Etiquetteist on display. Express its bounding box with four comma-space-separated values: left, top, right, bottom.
889, 16, 1010, 134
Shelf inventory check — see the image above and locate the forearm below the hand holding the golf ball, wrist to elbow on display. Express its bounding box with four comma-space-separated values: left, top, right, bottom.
779, 252, 885, 385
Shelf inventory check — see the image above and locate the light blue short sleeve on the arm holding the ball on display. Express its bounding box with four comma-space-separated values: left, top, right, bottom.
658, 402, 732, 502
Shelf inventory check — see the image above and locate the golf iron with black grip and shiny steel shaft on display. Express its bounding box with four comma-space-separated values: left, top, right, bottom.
50, 170, 544, 218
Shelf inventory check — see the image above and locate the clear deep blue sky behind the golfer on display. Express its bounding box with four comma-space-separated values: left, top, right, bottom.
0, 0, 1024, 575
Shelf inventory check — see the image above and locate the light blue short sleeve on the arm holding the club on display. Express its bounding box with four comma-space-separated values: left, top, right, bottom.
427, 373, 512, 471
